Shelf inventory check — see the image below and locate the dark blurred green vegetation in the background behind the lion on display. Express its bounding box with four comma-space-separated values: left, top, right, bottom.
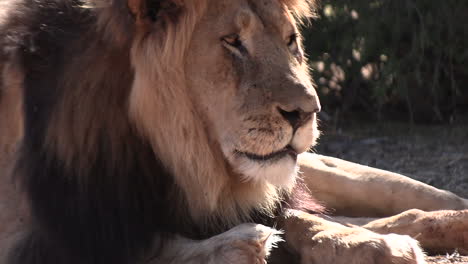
304, 0, 468, 123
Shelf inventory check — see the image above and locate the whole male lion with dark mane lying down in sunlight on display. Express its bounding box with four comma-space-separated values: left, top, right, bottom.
0, 0, 468, 264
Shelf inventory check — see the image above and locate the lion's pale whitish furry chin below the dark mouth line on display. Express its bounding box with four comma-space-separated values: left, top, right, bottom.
232, 155, 298, 188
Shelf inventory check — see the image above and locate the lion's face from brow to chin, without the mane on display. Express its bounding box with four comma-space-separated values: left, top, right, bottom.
185, 0, 320, 186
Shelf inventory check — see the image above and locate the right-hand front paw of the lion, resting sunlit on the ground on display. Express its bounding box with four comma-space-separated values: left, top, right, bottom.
301, 228, 426, 264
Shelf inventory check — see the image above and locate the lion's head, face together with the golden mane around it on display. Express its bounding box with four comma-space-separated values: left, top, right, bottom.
130, 0, 320, 214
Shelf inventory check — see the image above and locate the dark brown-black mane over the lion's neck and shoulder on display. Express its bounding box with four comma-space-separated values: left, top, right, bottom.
1, 0, 187, 264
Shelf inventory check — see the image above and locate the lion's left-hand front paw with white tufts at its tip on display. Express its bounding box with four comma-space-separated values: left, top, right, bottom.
213, 224, 282, 264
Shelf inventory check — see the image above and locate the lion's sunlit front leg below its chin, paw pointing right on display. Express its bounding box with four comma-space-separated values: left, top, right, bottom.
283, 210, 425, 264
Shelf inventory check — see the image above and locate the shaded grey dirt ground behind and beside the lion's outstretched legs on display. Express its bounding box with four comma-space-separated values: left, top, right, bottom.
315, 121, 468, 264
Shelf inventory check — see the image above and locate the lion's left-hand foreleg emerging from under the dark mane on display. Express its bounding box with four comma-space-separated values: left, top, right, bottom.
148, 224, 281, 264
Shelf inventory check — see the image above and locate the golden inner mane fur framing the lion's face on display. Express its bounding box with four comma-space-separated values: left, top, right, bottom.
125, 0, 322, 223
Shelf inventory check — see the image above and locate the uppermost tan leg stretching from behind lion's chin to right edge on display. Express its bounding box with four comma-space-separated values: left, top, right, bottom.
299, 153, 468, 217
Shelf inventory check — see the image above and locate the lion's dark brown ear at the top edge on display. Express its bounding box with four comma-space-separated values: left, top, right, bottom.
127, 0, 185, 25
